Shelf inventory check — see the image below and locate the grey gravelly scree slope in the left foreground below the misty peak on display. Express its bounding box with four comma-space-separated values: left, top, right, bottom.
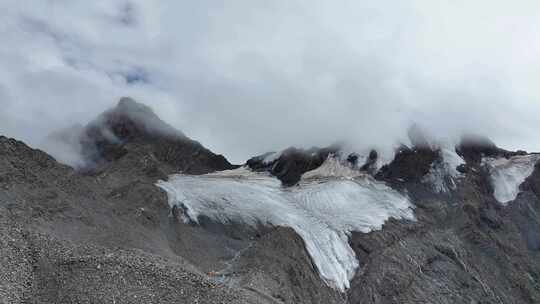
0, 137, 262, 303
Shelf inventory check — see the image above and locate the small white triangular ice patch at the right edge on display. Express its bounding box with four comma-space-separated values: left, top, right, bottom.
482, 154, 540, 205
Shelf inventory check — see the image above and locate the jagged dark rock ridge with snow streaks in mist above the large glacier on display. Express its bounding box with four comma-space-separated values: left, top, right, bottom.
246, 131, 527, 193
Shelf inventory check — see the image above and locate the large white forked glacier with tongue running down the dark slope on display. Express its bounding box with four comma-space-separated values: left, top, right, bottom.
158, 168, 414, 291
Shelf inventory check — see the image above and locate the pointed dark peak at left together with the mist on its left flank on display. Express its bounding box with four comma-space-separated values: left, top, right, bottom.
37, 97, 236, 176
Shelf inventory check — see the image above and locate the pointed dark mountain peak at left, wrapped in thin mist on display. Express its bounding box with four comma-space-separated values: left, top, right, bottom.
82, 97, 235, 174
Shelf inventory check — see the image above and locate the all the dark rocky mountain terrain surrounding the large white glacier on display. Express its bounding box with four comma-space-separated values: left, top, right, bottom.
0, 99, 540, 303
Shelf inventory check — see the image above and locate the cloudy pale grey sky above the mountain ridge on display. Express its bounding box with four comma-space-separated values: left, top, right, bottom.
0, 0, 540, 163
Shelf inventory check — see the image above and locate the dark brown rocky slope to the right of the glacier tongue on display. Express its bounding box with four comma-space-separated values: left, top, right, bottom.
349, 142, 540, 303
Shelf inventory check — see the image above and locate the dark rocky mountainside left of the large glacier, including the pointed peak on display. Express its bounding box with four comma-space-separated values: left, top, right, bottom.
0, 101, 343, 303
